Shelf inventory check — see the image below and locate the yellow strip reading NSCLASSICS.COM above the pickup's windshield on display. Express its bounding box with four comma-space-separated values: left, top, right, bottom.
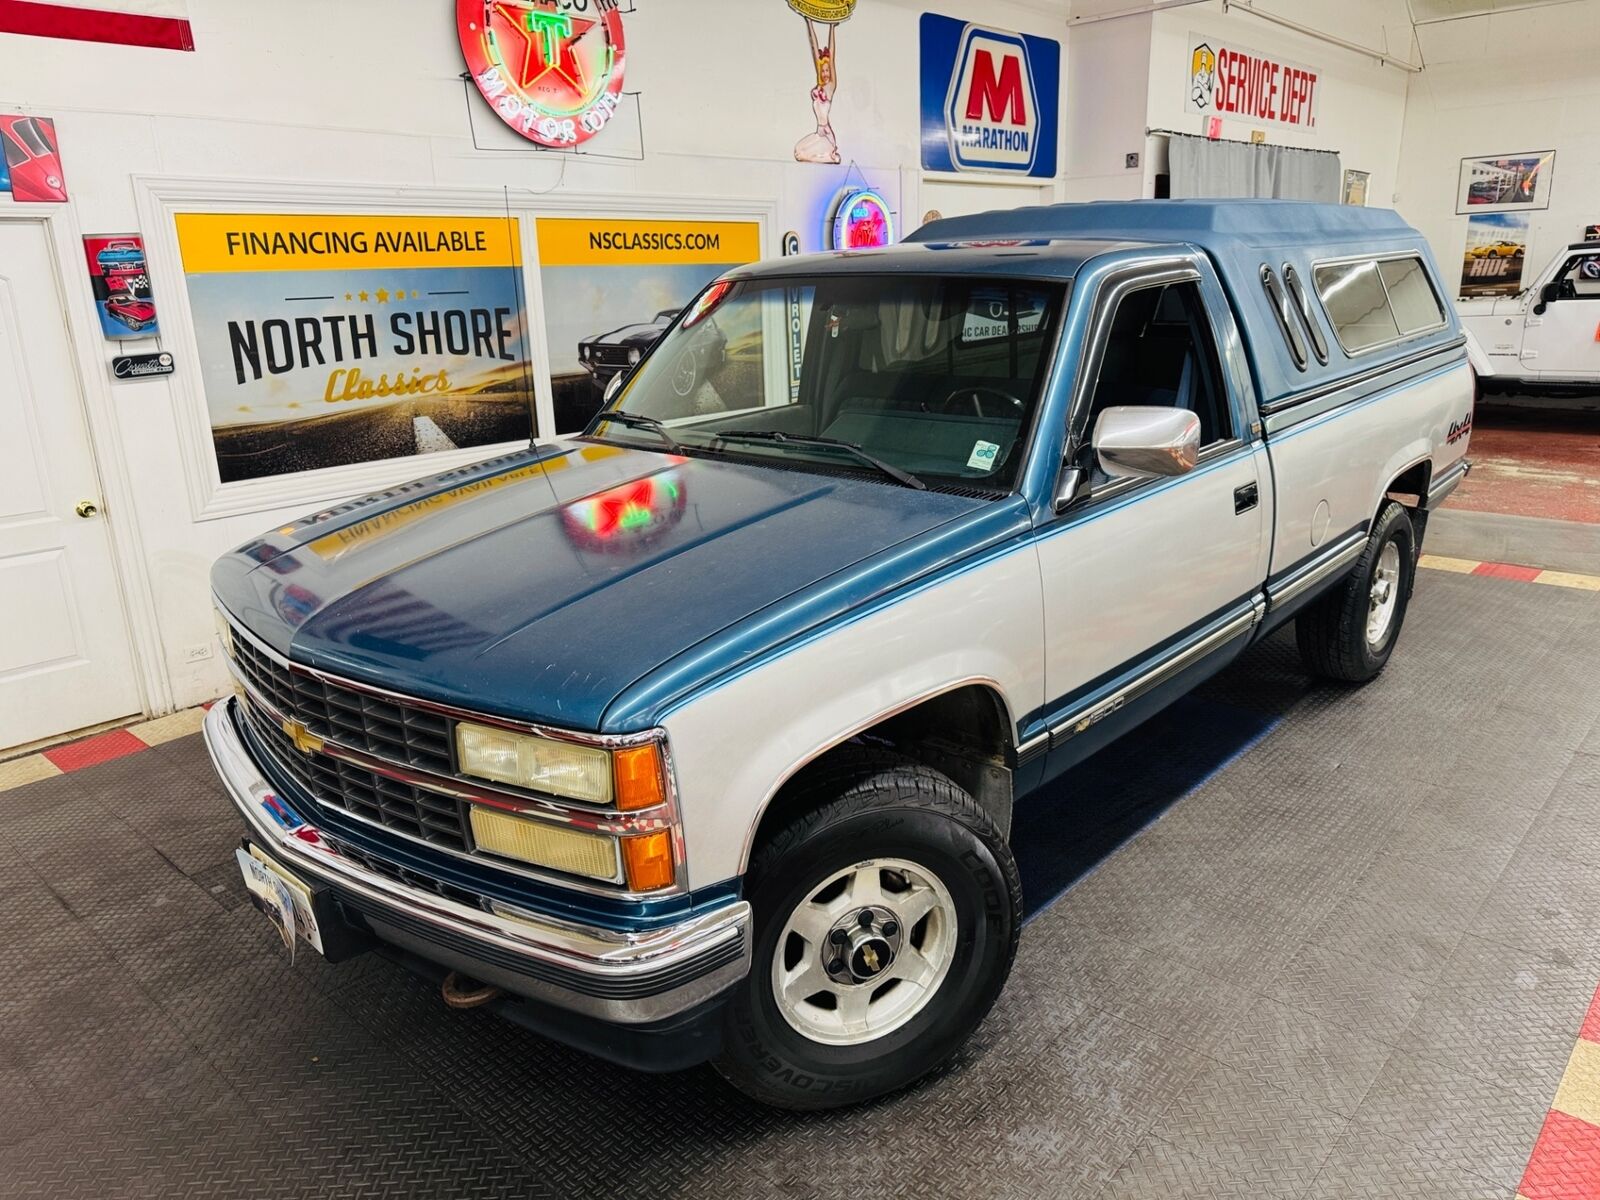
536, 218, 762, 267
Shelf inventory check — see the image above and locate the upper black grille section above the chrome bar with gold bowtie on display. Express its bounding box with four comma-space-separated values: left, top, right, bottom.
234, 629, 454, 776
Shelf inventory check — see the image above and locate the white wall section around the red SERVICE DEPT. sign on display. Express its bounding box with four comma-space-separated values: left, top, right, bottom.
1146, 0, 1416, 208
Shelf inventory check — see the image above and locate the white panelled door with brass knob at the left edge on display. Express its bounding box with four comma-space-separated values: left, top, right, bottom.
0, 219, 139, 750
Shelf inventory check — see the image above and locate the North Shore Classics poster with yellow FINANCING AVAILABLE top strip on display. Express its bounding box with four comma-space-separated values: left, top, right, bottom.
176, 213, 533, 483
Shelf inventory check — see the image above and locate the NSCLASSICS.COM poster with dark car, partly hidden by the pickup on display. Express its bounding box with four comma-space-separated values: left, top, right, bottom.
538, 218, 762, 434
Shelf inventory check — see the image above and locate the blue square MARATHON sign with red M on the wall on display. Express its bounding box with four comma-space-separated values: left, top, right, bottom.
920, 13, 1061, 178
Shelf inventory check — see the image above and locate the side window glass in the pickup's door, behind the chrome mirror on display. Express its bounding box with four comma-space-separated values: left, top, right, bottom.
1083, 280, 1238, 448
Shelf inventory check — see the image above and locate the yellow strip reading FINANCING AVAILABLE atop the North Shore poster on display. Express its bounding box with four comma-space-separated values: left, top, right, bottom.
176, 213, 521, 275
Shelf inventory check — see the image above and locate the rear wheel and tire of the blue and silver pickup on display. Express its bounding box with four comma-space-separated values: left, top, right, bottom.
1294, 501, 1416, 683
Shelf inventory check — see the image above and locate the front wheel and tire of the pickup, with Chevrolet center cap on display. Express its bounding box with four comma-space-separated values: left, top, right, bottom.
715, 747, 1022, 1109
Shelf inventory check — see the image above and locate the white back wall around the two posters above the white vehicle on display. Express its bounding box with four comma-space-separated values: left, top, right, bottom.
1395, 3, 1600, 285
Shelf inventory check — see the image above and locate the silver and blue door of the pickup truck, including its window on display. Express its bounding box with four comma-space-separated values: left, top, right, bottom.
1038, 256, 1272, 774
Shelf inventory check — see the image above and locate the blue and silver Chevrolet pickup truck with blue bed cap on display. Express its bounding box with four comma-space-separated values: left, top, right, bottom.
206, 202, 1472, 1107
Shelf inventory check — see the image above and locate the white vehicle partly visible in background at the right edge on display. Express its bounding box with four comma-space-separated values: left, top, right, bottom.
1456, 242, 1600, 400
